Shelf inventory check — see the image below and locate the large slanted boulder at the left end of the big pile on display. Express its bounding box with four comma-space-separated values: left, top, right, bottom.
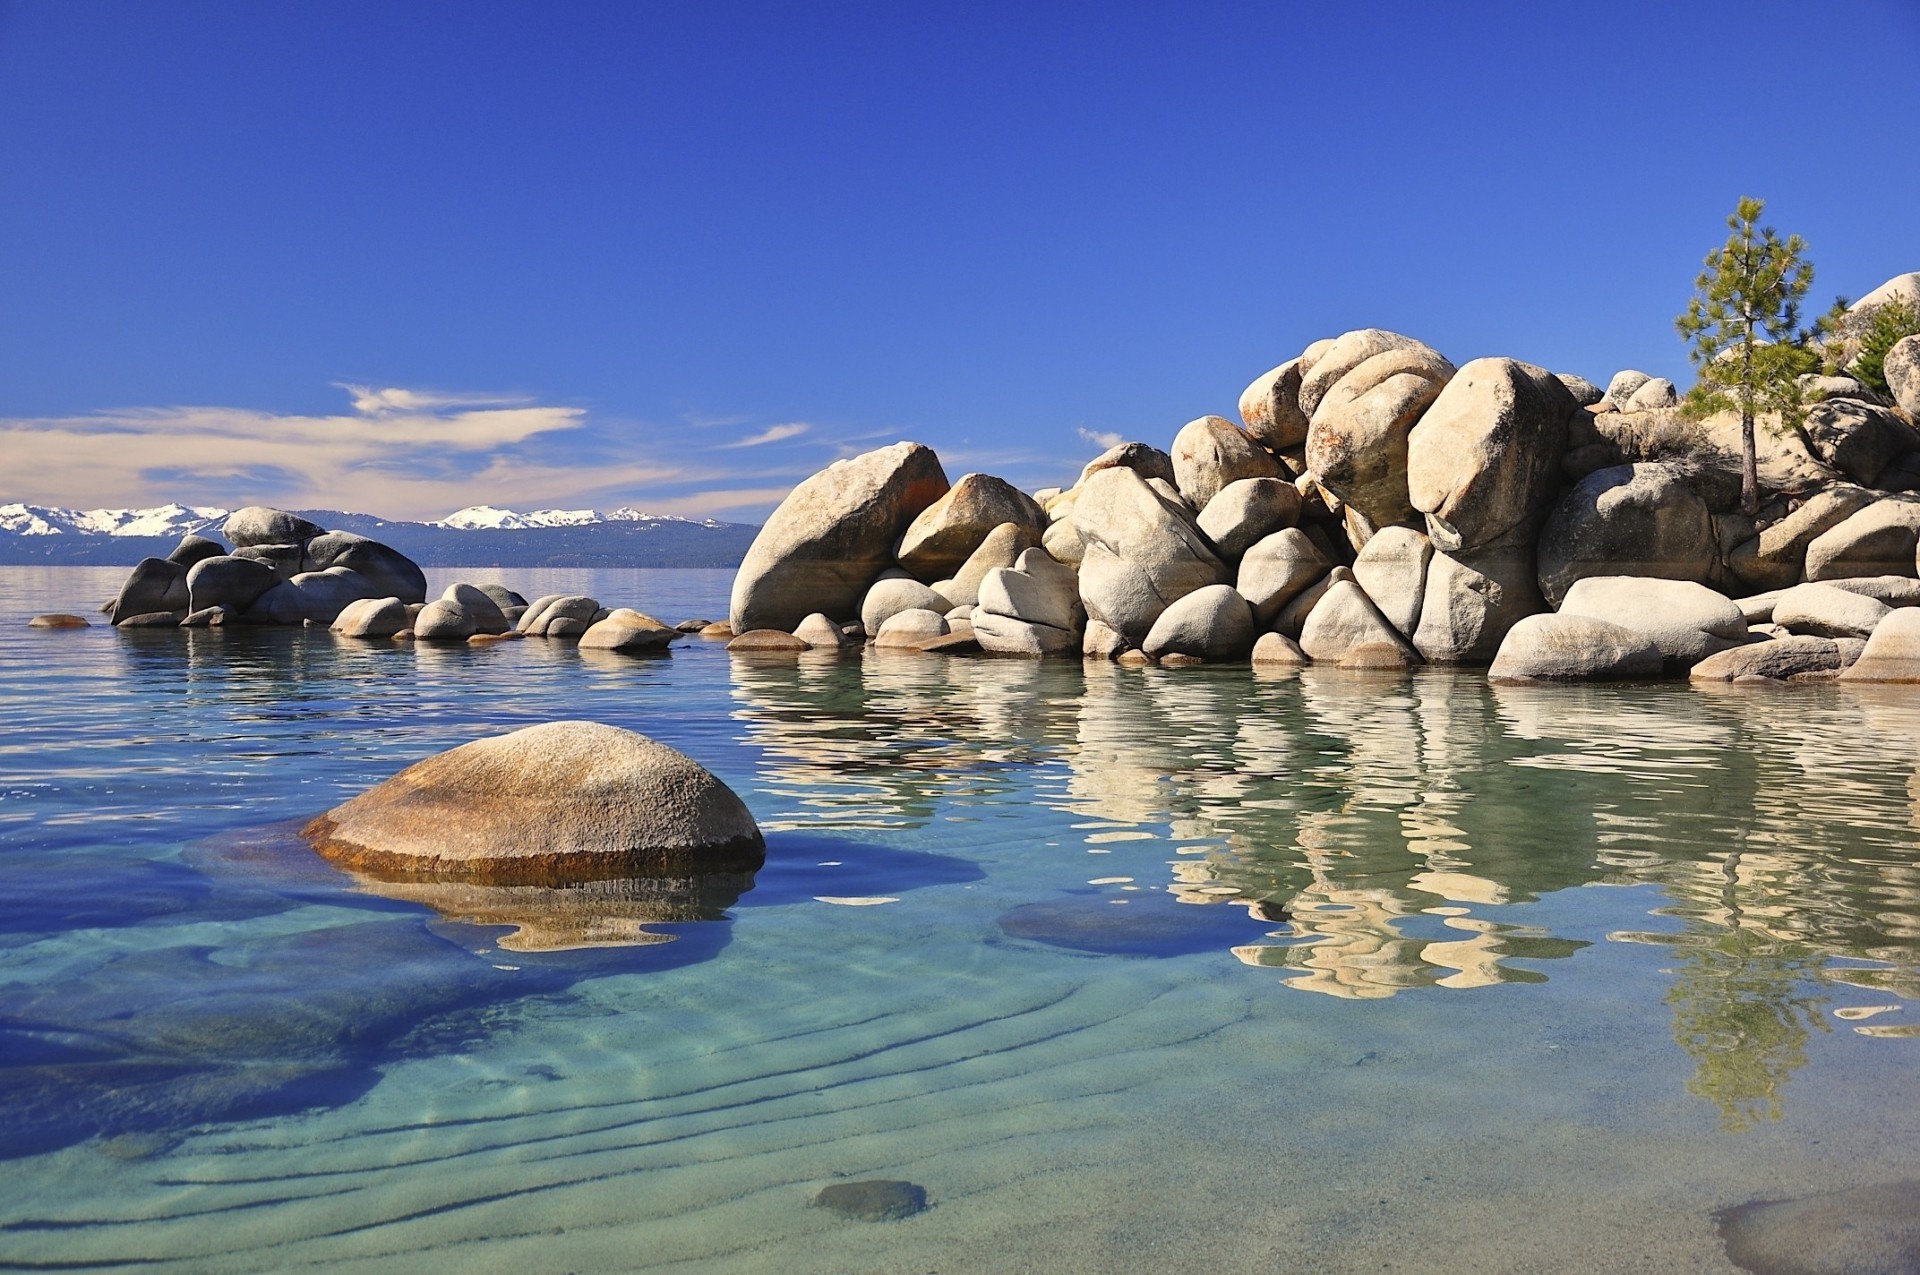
730, 442, 948, 634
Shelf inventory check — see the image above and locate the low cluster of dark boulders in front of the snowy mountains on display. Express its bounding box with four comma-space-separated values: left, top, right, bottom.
97, 505, 687, 651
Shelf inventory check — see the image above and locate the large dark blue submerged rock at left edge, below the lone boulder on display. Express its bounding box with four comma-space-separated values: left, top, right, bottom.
0, 922, 572, 1158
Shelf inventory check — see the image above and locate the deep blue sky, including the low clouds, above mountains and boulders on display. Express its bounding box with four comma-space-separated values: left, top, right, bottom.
0, 0, 1920, 520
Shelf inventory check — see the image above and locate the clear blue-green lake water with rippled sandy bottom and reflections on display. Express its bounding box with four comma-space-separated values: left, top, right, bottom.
0, 568, 1920, 1271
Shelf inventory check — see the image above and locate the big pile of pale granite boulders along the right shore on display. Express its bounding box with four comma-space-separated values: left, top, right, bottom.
730, 299, 1920, 682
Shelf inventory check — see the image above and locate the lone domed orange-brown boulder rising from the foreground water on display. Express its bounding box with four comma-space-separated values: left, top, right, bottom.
303, 722, 766, 885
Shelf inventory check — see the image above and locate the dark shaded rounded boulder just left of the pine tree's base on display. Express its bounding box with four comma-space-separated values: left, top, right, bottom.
1536, 462, 1720, 605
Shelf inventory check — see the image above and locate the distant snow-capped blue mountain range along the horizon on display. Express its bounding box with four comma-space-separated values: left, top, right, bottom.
0, 505, 760, 566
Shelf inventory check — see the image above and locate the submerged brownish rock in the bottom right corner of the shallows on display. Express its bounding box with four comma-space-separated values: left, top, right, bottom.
1715, 1181, 1920, 1275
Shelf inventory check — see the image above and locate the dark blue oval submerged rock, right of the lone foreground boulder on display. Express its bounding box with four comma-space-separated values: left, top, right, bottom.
1000, 891, 1273, 956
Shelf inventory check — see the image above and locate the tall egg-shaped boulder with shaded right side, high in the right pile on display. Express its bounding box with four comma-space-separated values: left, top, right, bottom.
1407, 359, 1578, 553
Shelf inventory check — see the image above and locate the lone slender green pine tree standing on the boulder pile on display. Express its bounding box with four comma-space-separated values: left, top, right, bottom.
1674, 196, 1816, 513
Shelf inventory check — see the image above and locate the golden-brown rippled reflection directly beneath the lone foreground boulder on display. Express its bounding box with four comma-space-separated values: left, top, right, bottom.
345, 872, 753, 952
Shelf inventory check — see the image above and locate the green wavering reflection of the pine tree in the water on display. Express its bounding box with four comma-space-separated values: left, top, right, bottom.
1667, 910, 1828, 1133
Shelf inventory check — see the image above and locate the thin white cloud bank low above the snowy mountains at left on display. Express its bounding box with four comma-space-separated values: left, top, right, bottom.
0, 384, 833, 518
